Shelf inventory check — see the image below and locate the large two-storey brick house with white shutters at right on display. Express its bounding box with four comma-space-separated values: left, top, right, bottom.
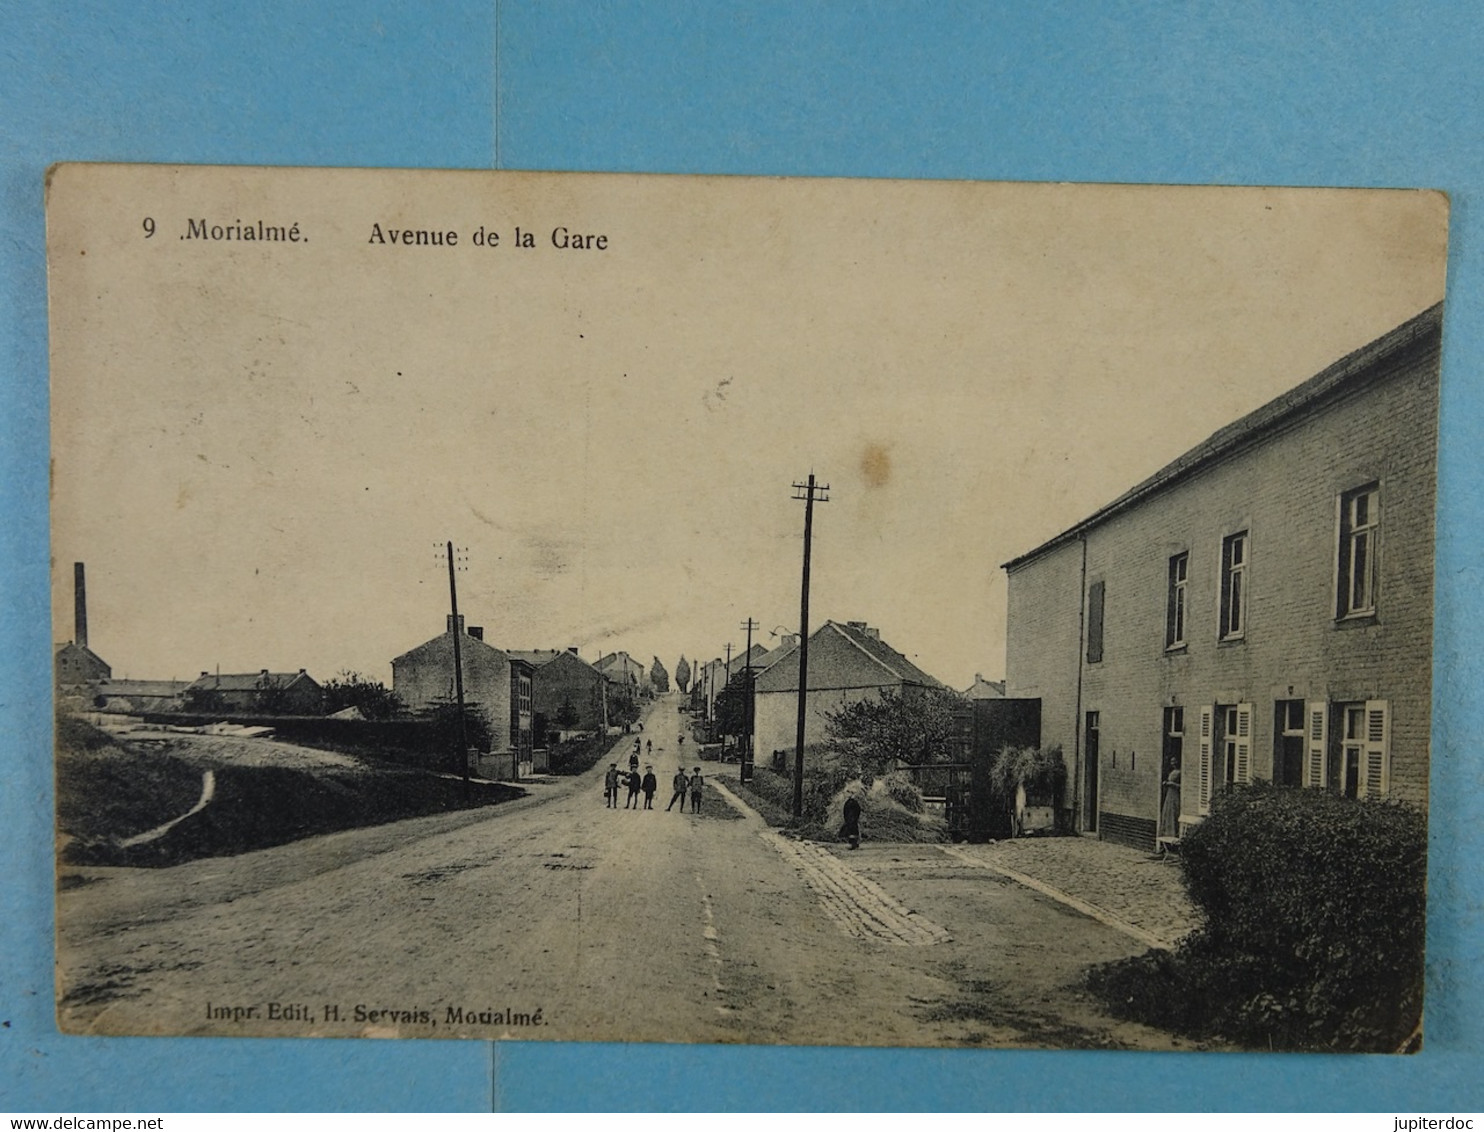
1005, 306, 1442, 849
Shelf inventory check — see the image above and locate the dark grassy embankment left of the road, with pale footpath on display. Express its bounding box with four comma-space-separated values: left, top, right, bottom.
56, 717, 524, 866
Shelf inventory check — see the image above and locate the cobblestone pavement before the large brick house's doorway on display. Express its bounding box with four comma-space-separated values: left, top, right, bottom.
942, 837, 1199, 947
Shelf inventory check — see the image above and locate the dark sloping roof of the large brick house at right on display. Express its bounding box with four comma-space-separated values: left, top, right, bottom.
1000, 303, 1442, 570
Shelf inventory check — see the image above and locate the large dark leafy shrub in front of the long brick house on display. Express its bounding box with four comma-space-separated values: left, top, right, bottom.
1091, 785, 1426, 1052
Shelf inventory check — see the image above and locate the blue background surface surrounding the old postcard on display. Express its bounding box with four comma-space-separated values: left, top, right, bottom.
0, 0, 1484, 1111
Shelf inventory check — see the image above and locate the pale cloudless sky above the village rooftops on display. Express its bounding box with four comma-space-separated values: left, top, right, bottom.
47, 166, 1447, 687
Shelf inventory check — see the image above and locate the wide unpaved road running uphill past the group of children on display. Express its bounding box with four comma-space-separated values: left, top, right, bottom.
58, 699, 1178, 1047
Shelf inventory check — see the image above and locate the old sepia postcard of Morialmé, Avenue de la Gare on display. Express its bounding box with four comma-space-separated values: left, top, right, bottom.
47, 165, 1447, 1052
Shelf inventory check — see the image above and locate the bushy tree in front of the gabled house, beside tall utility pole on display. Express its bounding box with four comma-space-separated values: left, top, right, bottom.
825, 688, 963, 779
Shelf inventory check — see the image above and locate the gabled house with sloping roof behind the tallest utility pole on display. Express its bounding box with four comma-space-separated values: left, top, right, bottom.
752, 622, 942, 761
